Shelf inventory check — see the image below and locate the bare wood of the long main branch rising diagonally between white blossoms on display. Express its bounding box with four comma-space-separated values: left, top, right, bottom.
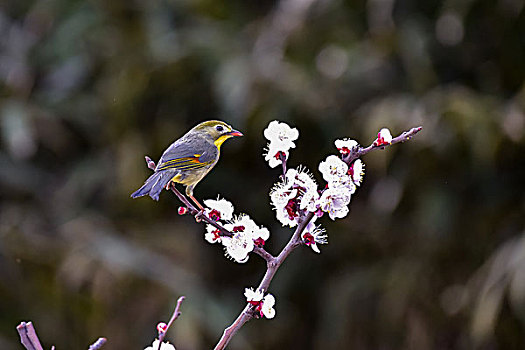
211, 127, 422, 350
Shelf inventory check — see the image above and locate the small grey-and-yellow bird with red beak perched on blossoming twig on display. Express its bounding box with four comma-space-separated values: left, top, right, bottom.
131, 120, 243, 210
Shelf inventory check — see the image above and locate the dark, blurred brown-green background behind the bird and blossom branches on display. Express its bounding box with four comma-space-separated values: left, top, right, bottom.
0, 0, 525, 350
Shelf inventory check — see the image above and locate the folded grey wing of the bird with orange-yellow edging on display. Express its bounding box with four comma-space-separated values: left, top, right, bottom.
156, 140, 216, 171
